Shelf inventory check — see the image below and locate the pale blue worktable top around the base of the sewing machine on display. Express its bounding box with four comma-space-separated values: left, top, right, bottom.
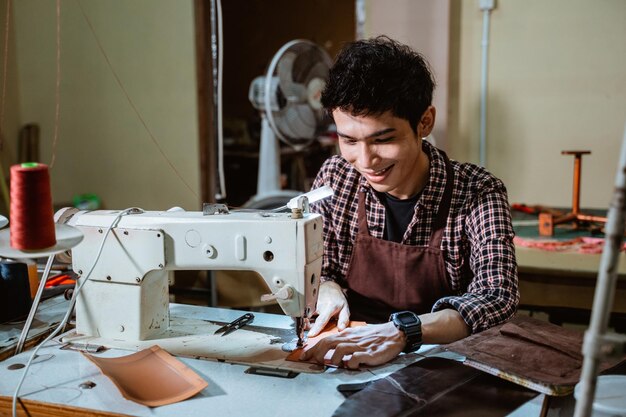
0, 304, 542, 417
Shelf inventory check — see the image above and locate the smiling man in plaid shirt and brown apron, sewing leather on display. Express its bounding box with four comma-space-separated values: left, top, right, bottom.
301, 37, 519, 368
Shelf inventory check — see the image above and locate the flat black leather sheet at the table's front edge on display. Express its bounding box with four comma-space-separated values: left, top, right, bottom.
333, 357, 537, 417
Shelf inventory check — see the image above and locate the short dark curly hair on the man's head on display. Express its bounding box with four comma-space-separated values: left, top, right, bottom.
321, 36, 435, 132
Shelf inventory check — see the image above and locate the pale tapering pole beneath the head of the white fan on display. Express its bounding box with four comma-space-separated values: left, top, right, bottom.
257, 114, 281, 198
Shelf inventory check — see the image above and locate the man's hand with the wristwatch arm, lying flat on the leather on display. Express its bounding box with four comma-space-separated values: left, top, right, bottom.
300, 322, 406, 369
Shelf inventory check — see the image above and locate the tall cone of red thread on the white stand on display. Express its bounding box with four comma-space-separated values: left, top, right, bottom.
10, 162, 56, 250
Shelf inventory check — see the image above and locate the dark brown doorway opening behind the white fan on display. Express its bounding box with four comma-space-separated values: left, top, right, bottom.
222, 0, 356, 207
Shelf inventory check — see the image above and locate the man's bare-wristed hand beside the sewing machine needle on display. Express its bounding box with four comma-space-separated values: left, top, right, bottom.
308, 281, 350, 337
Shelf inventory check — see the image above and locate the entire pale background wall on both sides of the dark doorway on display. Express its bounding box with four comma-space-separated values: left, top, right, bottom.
2, 0, 626, 209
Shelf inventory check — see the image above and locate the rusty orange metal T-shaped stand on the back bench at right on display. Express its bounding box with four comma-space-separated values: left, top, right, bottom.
539, 151, 606, 236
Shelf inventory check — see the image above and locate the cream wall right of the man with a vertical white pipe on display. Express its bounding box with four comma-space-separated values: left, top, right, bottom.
450, 0, 626, 208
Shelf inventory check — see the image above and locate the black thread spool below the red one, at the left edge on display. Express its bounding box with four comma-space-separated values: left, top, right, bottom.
0, 261, 32, 323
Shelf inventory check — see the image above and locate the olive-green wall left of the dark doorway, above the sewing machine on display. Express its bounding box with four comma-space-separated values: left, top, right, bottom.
12, 0, 200, 210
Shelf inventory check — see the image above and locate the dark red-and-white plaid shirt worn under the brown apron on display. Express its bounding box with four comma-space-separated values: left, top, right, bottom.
312, 141, 519, 333
